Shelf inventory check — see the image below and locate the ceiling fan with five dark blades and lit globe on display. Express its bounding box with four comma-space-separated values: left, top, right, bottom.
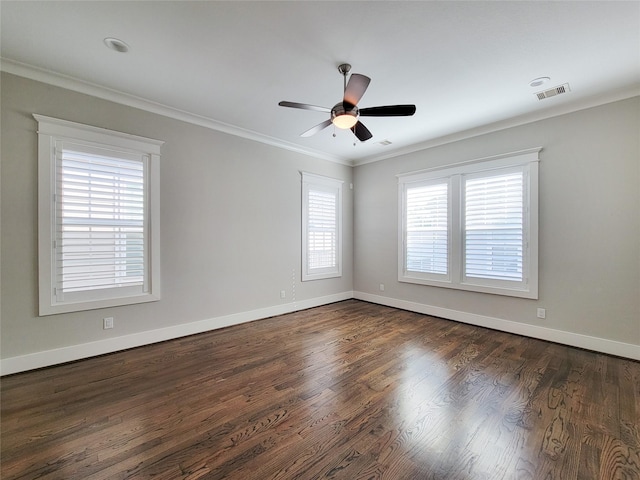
278, 63, 416, 142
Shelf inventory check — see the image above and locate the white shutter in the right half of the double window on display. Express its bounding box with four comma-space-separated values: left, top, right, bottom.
464, 171, 524, 282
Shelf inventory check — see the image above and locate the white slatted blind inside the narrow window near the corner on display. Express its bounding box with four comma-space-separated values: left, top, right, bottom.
307, 189, 338, 270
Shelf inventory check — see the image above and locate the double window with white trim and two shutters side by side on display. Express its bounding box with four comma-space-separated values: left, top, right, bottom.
398, 149, 540, 298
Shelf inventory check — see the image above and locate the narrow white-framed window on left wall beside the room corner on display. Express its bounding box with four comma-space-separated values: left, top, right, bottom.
302, 173, 342, 281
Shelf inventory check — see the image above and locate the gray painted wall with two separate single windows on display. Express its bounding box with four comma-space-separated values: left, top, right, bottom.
1, 73, 353, 358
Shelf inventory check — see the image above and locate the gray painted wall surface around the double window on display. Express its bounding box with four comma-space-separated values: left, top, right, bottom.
354, 98, 640, 345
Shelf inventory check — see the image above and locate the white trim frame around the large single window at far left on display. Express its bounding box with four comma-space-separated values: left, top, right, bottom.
33, 114, 164, 316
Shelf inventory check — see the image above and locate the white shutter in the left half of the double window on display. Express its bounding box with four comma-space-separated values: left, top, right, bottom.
405, 182, 449, 275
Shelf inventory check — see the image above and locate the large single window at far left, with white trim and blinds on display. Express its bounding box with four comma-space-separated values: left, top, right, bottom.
34, 115, 162, 315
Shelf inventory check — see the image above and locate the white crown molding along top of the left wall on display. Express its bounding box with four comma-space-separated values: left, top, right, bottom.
0, 57, 353, 166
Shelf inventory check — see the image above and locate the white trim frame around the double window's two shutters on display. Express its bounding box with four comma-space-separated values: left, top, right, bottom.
397, 147, 542, 299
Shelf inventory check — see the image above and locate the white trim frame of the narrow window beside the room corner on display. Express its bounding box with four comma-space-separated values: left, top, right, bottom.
301, 172, 344, 282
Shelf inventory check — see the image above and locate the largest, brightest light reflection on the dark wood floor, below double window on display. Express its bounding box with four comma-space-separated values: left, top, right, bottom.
398, 345, 524, 478
